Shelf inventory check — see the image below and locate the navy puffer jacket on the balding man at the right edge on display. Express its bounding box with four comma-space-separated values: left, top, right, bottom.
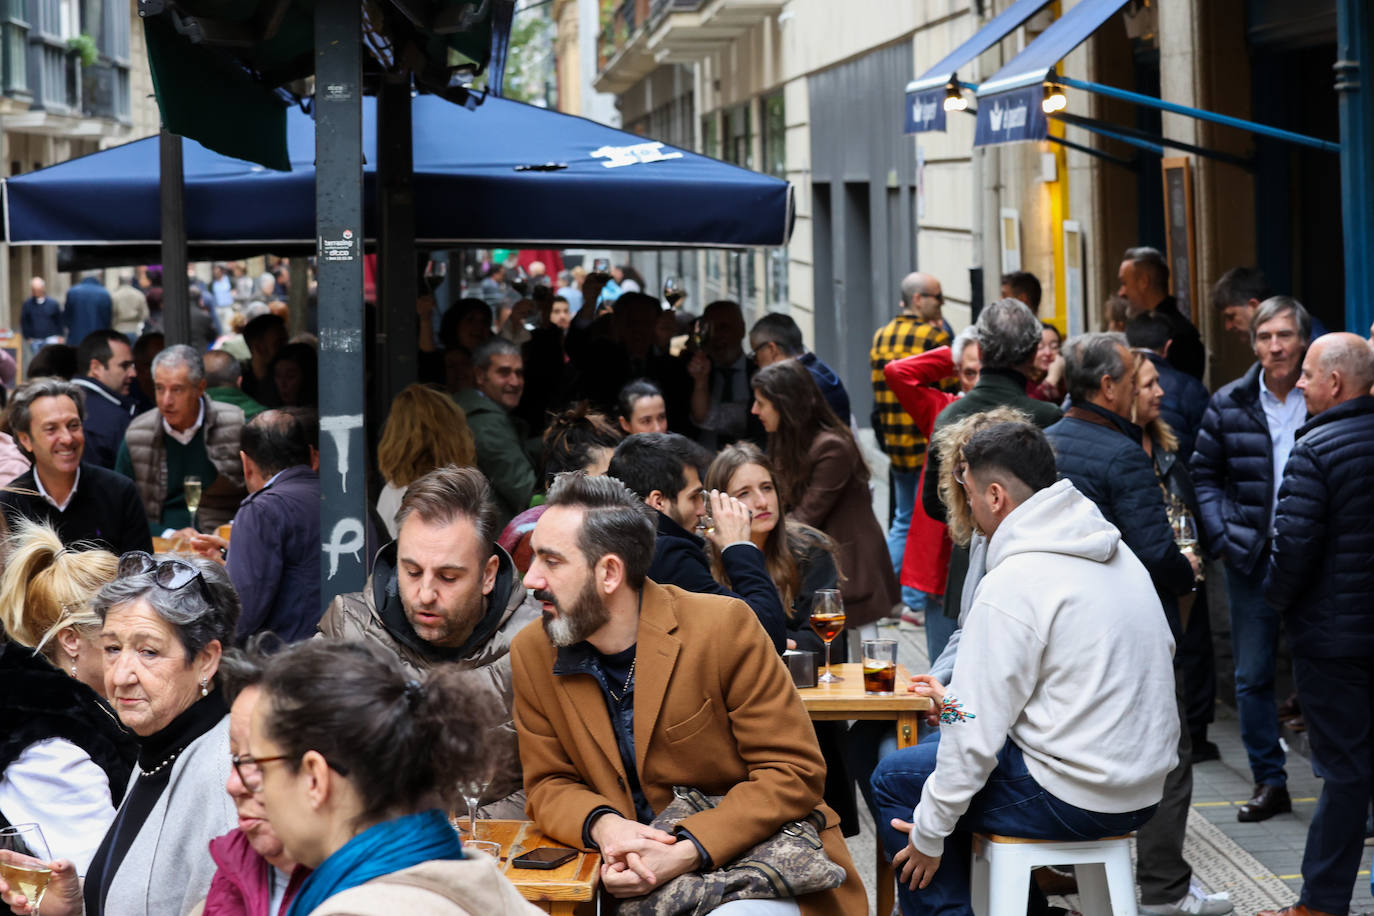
1264, 394, 1374, 658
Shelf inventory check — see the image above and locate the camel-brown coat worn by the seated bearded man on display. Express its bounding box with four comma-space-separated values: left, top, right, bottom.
511, 581, 867, 916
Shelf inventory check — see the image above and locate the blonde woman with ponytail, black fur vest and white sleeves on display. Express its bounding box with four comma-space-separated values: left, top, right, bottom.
0, 519, 137, 872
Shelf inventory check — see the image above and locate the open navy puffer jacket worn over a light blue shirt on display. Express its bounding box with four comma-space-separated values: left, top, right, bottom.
1189, 363, 1269, 575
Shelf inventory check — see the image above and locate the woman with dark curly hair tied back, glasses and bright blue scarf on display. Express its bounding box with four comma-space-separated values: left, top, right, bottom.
234, 640, 539, 916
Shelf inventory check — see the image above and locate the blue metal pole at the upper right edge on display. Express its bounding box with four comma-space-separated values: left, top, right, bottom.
1336, 0, 1374, 329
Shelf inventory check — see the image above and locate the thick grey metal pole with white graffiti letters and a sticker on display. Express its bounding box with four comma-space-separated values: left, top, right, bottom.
314, 3, 368, 606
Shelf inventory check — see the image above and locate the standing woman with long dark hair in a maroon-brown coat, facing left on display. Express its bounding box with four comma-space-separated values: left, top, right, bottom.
750, 360, 900, 628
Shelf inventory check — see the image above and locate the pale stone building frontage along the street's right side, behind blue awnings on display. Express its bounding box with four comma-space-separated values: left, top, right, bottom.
583, 0, 1370, 417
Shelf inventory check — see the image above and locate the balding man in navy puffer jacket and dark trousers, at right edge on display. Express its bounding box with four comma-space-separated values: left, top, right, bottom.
1260, 334, 1374, 916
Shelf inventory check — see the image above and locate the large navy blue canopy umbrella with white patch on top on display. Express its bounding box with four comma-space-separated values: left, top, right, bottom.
3, 95, 793, 253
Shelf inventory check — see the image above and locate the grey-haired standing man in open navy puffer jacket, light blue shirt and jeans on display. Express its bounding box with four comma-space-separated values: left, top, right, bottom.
1189, 295, 1312, 821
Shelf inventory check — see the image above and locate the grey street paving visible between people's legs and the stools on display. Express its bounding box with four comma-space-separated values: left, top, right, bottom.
848, 623, 1374, 916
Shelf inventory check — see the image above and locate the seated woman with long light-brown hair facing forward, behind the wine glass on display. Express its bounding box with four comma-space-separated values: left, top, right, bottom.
705, 442, 859, 836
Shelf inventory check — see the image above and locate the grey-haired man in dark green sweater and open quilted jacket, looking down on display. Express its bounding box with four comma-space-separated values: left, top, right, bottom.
114, 343, 247, 537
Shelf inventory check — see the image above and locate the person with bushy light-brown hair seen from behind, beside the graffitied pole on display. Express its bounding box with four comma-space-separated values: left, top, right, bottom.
376, 385, 477, 538
